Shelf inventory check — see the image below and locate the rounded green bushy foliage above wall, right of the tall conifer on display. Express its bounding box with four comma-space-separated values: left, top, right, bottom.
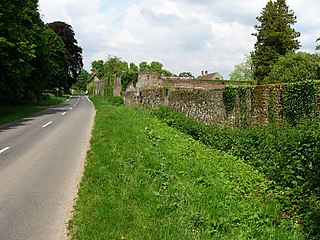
266, 52, 320, 83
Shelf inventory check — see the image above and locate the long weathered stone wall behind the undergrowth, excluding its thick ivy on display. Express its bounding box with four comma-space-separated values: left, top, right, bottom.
123, 82, 320, 126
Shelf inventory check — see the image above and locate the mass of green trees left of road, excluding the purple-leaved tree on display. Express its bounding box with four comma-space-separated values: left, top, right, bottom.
0, 0, 67, 104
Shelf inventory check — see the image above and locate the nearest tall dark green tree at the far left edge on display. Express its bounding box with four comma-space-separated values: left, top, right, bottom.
0, 0, 36, 103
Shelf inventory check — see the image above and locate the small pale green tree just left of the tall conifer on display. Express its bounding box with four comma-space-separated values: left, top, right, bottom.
230, 55, 253, 81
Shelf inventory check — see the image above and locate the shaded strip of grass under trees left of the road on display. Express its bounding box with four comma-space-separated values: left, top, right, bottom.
0, 95, 68, 126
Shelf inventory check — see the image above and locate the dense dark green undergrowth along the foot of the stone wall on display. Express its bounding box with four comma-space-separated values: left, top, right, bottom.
155, 107, 320, 239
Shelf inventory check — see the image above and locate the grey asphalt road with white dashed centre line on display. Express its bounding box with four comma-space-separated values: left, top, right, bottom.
0, 96, 94, 240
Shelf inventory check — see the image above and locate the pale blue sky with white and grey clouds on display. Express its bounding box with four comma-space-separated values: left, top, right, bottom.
39, 0, 320, 79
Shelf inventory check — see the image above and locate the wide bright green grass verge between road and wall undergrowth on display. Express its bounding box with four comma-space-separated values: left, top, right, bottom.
69, 98, 304, 240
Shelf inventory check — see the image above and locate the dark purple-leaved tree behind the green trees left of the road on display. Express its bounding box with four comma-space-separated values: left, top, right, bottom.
48, 21, 83, 88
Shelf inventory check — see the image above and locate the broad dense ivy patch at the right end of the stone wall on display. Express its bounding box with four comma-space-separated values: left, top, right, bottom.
282, 81, 318, 125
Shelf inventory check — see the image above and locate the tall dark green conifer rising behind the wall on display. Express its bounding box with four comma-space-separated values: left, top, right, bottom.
251, 0, 300, 84
